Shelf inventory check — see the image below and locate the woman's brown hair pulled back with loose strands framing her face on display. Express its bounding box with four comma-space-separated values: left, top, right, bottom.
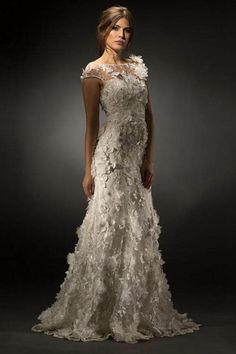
97, 6, 134, 55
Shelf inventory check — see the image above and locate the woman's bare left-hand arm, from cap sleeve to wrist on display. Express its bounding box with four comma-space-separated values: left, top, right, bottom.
82, 77, 100, 174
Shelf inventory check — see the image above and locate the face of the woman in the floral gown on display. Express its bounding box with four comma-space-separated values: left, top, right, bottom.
106, 17, 131, 52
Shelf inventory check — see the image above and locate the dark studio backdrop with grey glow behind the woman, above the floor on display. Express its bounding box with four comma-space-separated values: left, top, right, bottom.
1, 1, 236, 352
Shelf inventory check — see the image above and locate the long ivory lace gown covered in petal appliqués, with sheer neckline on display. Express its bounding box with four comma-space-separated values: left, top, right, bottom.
32, 54, 201, 343
